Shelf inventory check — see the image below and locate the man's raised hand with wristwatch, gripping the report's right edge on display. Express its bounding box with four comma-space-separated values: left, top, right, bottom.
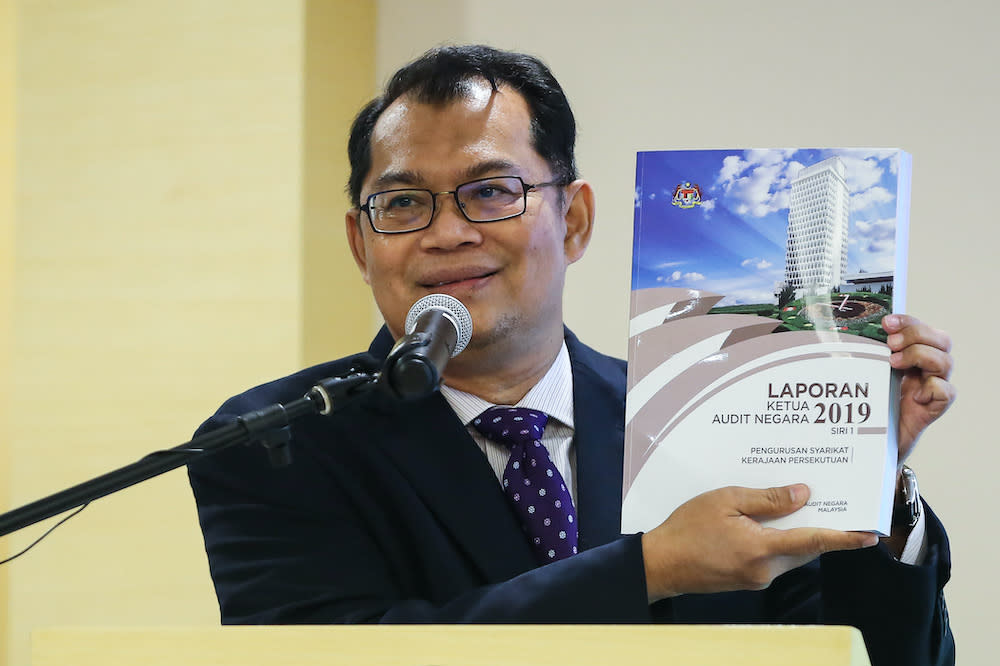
882, 314, 955, 464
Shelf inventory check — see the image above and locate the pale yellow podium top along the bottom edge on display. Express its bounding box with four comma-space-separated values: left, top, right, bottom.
31, 625, 869, 666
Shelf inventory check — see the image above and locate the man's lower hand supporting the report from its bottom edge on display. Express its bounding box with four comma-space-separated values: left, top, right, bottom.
642, 484, 878, 603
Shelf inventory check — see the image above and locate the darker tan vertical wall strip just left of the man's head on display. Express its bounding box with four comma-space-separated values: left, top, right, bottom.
301, 0, 376, 365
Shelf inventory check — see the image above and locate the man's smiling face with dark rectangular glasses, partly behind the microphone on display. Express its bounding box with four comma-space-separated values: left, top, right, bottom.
347, 81, 592, 358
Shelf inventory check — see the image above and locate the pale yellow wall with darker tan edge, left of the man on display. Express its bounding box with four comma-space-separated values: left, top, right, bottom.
0, 0, 374, 664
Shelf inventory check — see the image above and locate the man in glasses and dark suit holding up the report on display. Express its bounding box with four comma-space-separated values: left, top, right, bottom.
191, 47, 954, 664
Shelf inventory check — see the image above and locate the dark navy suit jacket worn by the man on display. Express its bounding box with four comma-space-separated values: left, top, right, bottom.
190, 329, 954, 664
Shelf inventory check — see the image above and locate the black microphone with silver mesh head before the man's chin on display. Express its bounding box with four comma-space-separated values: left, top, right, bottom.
381, 294, 472, 400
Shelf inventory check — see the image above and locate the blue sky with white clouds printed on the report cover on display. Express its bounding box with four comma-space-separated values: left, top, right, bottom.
632, 148, 899, 305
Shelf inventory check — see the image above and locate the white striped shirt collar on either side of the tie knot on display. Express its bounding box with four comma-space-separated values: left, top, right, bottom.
441, 341, 573, 428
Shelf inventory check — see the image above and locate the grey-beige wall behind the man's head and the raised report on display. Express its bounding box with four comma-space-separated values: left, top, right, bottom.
376, 0, 1000, 664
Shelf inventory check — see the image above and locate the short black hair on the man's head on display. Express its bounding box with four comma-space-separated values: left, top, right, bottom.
347, 45, 576, 204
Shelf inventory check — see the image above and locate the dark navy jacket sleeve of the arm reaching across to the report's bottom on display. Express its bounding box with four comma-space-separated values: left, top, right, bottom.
189, 410, 650, 624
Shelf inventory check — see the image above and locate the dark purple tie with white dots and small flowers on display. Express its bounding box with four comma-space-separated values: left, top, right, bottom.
472, 407, 577, 564
